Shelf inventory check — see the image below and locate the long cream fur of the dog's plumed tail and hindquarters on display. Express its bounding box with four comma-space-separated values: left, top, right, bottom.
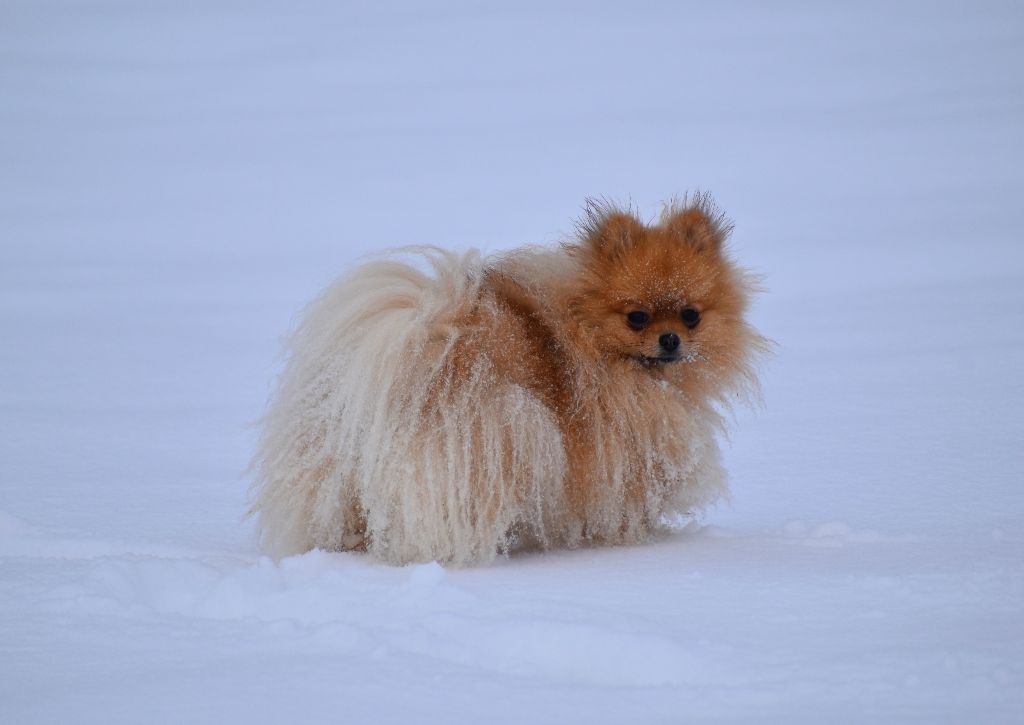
253, 248, 564, 564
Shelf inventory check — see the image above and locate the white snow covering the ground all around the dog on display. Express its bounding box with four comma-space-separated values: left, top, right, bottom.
0, 0, 1024, 723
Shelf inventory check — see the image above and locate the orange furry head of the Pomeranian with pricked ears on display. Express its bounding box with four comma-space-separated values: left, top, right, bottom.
567, 195, 760, 397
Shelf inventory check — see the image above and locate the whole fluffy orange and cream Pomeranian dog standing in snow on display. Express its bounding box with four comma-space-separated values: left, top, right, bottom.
253, 195, 766, 565
